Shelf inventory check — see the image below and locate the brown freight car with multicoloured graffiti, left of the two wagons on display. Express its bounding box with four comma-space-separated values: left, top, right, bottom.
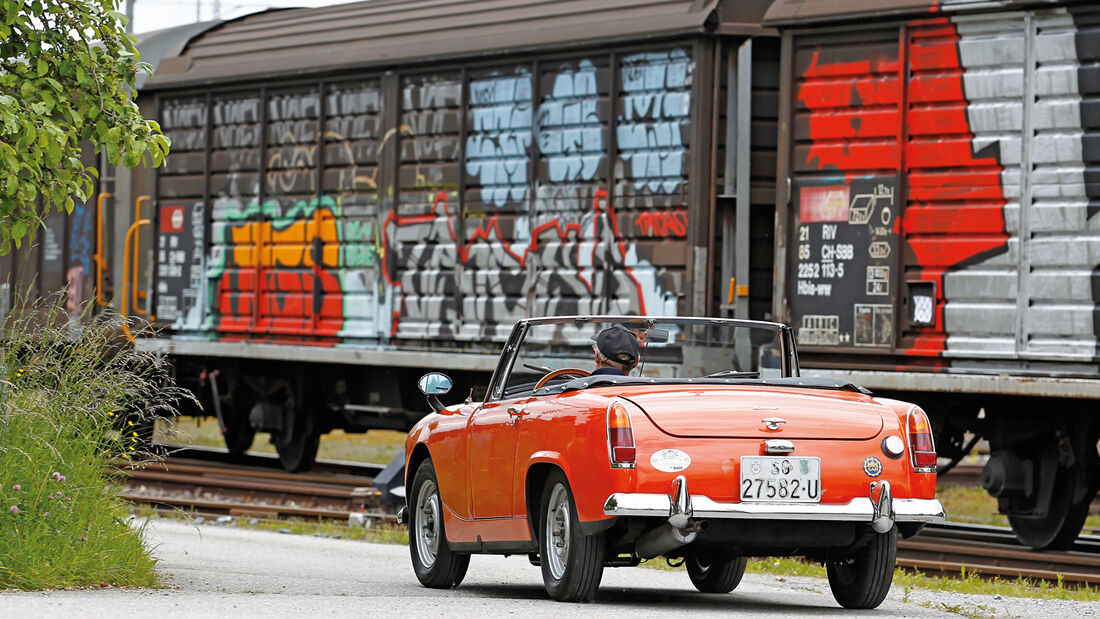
120, 0, 779, 469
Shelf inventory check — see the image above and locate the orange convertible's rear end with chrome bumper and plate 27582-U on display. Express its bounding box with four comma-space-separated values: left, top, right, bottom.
604, 385, 944, 561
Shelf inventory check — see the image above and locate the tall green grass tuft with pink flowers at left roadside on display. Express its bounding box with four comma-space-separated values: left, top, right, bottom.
0, 299, 189, 589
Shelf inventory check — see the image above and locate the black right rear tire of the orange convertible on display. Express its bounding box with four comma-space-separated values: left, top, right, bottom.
825, 527, 898, 609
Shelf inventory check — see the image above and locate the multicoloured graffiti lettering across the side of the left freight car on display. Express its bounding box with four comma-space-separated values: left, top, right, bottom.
162, 48, 693, 341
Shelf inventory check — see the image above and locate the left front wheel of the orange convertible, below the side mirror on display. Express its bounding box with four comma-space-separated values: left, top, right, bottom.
408, 460, 470, 589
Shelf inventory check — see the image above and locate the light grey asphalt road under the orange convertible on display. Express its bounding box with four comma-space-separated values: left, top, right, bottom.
0, 520, 1100, 619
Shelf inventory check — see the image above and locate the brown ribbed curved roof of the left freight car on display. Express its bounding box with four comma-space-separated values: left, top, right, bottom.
147, 0, 768, 88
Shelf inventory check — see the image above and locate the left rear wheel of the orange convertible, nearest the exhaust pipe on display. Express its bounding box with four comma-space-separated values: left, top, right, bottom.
538, 471, 606, 601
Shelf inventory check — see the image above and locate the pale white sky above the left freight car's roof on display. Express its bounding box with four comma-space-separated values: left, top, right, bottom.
125, 0, 352, 33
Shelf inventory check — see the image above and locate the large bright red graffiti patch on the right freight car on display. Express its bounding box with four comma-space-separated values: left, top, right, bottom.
795, 19, 1008, 355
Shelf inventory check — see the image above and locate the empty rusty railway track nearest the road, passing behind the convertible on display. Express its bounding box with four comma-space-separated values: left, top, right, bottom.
117, 450, 1100, 586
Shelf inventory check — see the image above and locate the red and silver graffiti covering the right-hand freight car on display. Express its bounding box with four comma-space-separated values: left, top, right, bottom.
792, 9, 1100, 358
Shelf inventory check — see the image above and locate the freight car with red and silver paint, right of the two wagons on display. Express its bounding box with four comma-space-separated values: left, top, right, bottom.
766, 0, 1100, 548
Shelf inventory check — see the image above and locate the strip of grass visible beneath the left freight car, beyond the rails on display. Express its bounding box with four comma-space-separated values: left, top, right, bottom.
155, 417, 405, 464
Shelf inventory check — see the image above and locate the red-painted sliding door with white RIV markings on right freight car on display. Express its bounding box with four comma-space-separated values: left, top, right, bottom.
788, 14, 1031, 357
